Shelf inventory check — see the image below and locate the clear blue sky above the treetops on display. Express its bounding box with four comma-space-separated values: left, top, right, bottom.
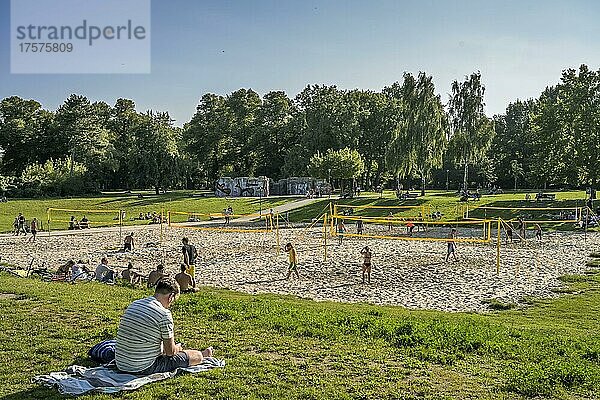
0, 0, 600, 125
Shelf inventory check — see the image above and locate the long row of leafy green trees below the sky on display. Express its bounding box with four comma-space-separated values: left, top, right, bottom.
0, 65, 600, 196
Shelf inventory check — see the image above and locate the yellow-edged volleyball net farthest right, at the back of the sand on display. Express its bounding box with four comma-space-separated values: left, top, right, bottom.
464, 206, 586, 224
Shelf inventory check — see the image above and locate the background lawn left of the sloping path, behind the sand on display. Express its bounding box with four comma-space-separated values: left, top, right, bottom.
0, 191, 293, 232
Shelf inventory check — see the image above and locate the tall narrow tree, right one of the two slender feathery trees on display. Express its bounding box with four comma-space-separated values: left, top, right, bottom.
448, 72, 494, 190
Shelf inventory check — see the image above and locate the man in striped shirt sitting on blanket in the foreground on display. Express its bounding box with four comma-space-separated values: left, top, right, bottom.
115, 278, 213, 375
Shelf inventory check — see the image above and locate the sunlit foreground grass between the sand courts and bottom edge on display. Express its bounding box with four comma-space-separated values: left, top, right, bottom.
0, 271, 600, 400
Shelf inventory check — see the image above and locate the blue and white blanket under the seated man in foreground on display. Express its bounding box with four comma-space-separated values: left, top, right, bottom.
32, 357, 225, 396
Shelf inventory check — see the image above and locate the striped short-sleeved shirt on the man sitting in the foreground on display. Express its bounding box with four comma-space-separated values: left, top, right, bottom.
115, 296, 174, 372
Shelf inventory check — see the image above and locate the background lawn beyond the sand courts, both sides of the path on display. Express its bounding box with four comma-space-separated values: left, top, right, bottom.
0, 191, 585, 232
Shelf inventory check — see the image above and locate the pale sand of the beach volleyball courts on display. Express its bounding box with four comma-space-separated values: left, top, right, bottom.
0, 225, 600, 311
